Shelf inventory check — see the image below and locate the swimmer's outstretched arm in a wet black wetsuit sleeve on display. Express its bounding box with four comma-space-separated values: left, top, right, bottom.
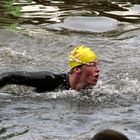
0, 71, 49, 87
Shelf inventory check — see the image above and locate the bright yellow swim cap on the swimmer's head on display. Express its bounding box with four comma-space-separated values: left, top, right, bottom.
69, 45, 96, 68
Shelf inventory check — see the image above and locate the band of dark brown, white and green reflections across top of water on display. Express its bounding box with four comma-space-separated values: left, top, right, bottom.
0, 0, 140, 27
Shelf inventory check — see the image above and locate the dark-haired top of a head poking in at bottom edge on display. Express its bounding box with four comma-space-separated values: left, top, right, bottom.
91, 129, 129, 140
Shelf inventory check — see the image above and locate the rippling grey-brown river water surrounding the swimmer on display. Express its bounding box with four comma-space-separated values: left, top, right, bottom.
0, 0, 140, 140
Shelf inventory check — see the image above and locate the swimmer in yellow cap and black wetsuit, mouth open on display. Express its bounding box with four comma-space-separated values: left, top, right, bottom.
0, 45, 100, 92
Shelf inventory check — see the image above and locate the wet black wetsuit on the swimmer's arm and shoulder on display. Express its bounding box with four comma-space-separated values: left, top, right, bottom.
0, 71, 70, 92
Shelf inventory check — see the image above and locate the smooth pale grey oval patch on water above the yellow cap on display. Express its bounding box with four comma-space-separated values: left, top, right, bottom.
48, 16, 119, 33
